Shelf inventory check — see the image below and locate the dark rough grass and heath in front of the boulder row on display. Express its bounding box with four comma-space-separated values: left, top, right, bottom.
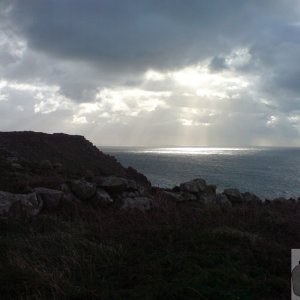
0, 195, 300, 300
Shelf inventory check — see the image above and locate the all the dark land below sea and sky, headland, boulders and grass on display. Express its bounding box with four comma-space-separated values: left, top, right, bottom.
0, 132, 300, 299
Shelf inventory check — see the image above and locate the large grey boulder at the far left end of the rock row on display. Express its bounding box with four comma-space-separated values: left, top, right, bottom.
0, 192, 43, 219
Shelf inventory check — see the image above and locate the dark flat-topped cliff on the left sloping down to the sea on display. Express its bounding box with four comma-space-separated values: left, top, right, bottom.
0, 131, 150, 190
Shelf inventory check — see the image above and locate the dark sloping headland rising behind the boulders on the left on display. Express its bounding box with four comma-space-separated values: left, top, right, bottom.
0, 131, 150, 190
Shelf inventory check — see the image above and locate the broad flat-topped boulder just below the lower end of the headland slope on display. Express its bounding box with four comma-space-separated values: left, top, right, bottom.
98, 176, 138, 193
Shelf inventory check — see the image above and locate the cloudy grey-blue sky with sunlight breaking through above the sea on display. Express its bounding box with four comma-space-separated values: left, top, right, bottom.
0, 0, 300, 146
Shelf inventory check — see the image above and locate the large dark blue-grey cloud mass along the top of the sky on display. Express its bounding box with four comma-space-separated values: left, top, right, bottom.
8, 0, 298, 70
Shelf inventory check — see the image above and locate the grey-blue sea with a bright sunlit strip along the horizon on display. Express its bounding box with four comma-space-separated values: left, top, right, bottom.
99, 147, 300, 198
